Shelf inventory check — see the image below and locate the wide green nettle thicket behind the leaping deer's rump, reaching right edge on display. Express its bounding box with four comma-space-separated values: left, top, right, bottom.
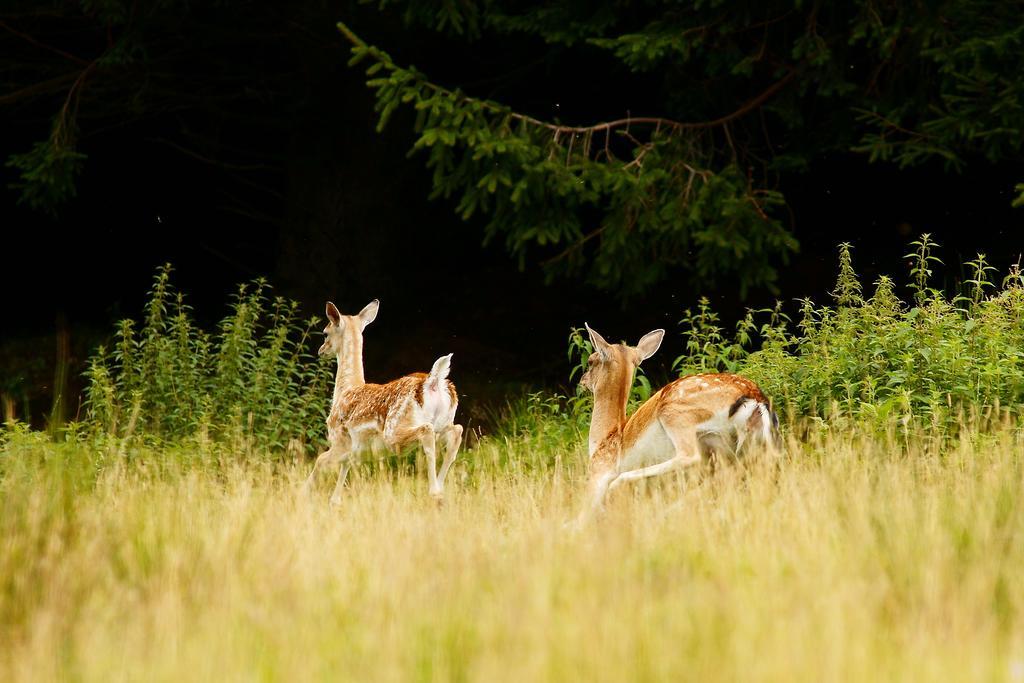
676, 240, 1024, 426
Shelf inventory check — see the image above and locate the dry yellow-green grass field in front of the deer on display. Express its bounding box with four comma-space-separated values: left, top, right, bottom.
0, 426, 1024, 681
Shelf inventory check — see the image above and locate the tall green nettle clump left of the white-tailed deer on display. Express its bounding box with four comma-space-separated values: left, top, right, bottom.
86, 265, 331, 451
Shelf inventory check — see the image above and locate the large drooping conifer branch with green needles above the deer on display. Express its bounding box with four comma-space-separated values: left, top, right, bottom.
339, 25, 797, 297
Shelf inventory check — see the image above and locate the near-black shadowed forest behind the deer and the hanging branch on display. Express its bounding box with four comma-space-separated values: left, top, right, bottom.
0, 0, 1024, 422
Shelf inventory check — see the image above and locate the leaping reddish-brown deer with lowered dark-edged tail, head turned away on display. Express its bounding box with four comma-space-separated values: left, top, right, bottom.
577, 323, 778, 526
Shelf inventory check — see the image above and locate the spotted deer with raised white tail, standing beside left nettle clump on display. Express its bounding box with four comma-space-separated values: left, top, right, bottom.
304, 299, 462, 506
